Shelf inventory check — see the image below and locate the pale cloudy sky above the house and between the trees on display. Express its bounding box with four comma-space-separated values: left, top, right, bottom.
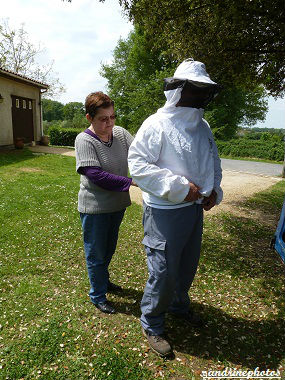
0, 0, 285, 128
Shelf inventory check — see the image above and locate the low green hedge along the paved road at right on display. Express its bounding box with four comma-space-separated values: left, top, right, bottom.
216, 138, 284, 161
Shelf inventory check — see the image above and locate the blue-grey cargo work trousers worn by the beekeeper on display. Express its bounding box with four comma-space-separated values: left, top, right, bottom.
141, 204, 203, 335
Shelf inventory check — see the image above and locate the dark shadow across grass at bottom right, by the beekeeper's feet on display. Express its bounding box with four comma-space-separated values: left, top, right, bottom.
167, 304, 285, 370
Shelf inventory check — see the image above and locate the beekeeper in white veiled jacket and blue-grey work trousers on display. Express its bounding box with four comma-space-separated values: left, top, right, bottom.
128, 59, 223, 356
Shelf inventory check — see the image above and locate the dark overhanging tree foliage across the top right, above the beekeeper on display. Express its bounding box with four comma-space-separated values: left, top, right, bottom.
99, 0, 285, 97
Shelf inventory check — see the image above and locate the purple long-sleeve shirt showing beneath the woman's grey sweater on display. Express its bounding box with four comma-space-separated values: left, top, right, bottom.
78, 129, 132, 191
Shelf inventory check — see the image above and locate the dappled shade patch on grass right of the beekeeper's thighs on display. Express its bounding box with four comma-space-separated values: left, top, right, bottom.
201, 214, 282, 279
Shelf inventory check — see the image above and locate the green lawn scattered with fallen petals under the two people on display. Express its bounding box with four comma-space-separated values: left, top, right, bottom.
0, 150, 285, 380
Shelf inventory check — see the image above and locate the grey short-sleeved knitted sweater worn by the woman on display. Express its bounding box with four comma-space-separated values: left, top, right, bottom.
75, 126, 133, 214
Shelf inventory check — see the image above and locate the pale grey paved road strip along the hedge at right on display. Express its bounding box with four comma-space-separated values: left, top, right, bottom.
222, 158, 282, 177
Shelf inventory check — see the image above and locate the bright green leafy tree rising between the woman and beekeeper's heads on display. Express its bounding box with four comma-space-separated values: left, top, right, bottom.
101, 29, 173, 133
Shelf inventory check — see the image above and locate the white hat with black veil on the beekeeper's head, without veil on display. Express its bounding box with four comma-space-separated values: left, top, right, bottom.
173, 58, 217, 84
